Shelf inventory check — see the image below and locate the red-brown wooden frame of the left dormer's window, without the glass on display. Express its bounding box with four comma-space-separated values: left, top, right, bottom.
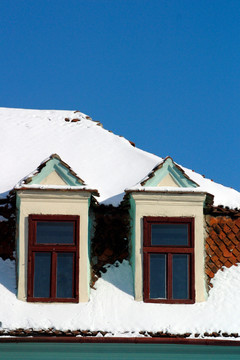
27, 214, 80, 303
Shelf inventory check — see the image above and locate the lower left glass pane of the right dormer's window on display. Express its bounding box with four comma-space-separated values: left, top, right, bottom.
150, 254, 166, 299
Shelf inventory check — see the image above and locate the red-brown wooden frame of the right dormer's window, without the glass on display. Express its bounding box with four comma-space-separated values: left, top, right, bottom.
143, 216, 195, 304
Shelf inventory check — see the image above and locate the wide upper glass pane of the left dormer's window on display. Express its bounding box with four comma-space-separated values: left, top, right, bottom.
36, 221, 74, 244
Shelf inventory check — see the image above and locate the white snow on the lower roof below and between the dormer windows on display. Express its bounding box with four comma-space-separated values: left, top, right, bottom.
0, 259, 240, 337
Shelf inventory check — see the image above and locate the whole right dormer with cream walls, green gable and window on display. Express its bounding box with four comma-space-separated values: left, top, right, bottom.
126, 157, 209, 304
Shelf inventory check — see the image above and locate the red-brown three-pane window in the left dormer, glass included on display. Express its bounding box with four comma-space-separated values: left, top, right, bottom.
27, 215, 79, 302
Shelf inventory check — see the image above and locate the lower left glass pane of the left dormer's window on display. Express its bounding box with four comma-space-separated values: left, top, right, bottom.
33, 253, 51, 297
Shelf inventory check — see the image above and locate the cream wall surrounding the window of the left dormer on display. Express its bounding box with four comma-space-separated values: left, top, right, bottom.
18, 189, 90, 302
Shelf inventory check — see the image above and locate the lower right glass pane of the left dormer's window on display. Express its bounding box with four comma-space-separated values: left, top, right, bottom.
57, 253, 74, 298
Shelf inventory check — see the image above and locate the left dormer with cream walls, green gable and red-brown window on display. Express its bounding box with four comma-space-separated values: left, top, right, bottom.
15, 154, 98, 302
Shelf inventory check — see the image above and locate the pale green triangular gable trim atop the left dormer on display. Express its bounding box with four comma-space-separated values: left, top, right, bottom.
25, 154, 85, 186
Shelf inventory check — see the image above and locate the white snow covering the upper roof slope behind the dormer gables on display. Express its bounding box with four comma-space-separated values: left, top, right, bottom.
0, 108, 240, 208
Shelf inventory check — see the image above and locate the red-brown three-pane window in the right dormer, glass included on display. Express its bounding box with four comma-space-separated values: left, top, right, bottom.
143, 217, 195, 303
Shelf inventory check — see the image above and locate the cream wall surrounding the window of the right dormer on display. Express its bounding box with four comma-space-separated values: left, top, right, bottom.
132, 192, 207, 302
